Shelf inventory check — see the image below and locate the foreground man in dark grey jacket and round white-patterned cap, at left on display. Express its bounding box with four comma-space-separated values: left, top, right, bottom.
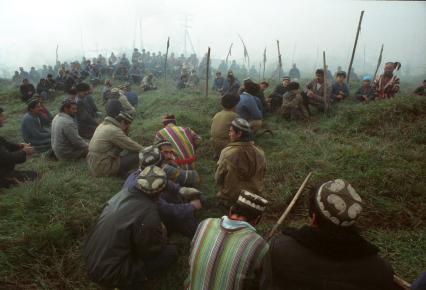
84, 166, 177, 290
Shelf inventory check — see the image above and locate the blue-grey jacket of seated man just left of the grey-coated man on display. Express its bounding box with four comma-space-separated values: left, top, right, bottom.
21, 112, 50, 146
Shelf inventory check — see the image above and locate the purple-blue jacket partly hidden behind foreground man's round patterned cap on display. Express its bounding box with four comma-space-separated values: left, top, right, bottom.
123, 170, 195, 219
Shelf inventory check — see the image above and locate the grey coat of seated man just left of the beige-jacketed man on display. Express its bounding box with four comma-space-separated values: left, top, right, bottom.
52, 113, 89, 160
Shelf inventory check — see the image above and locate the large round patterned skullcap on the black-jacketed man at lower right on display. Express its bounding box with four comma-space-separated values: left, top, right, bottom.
315, 179, 362, 227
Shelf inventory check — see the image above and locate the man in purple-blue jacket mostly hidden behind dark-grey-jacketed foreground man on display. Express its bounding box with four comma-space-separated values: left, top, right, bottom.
123, 145, 204, 238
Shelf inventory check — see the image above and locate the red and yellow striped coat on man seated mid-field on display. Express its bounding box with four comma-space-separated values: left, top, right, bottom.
155, 124, 200, 169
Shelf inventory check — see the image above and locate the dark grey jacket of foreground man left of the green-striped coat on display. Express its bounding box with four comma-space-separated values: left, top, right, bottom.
84, 187, 166, 287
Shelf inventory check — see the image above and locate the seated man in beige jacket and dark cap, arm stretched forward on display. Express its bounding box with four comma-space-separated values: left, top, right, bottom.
87, 112, 143, 176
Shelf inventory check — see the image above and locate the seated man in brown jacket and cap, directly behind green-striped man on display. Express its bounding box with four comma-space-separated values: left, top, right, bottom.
215, 118, 266, 206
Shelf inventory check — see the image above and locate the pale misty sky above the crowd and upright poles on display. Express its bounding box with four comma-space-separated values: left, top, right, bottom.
0, 0, 426, 75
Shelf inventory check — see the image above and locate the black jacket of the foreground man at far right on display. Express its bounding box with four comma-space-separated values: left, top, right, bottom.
271, 226, 393, 290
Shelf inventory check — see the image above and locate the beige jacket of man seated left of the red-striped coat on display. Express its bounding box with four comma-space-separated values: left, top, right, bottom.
87, 117, 143, 176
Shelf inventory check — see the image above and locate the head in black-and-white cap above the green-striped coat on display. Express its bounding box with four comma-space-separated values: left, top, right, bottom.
229, 190, 268, 226
